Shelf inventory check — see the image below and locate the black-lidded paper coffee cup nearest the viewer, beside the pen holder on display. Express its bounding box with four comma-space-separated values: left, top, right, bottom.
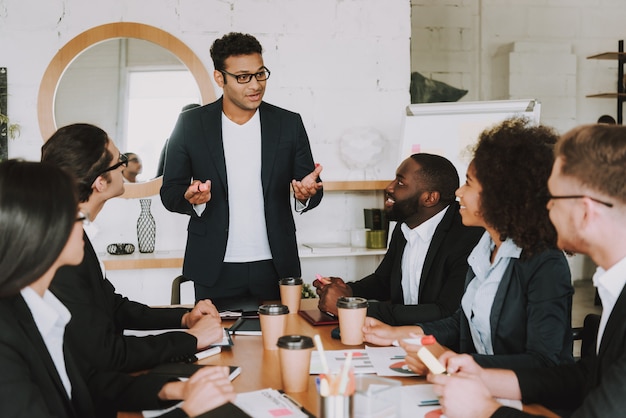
276, 335, 313, 392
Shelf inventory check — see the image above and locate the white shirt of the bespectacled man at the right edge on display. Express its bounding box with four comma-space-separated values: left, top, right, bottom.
593, 258, 626, 353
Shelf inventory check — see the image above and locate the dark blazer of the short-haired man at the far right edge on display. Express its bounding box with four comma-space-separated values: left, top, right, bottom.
494, 280, 626, 417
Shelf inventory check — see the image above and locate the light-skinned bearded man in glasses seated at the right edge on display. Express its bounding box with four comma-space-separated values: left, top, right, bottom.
428, 124, 626, 418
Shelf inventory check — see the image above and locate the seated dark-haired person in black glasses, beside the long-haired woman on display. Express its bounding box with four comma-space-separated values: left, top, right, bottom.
41, 124, 223, 378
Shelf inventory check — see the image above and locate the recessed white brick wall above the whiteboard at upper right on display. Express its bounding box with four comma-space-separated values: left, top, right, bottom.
411, 0, 626, 130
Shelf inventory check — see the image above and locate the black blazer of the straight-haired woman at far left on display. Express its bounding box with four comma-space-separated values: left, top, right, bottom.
0, 294, 214, 418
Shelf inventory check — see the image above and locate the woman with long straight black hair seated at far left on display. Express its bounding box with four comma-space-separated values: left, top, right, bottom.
0, 160, 234, 418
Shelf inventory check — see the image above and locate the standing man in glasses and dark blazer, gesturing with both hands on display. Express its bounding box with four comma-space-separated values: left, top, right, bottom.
161, 33, 323, 310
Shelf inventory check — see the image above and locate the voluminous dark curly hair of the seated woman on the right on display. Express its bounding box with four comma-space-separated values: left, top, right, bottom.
473, 117, 558, 258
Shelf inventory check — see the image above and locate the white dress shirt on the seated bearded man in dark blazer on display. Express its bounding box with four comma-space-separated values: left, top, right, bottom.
400, 206, 450, 305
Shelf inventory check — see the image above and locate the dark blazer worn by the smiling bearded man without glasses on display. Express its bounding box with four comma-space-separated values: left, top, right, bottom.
348, 202, 484, 325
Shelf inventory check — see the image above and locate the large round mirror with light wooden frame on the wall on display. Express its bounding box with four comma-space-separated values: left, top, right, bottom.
37, 22, 215, 198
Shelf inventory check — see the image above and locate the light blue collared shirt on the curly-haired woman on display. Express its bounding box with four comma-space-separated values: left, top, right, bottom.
461, 232, 522, 354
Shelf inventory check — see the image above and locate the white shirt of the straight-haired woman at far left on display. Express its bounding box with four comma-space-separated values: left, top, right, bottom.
20, 286, 72, 399
